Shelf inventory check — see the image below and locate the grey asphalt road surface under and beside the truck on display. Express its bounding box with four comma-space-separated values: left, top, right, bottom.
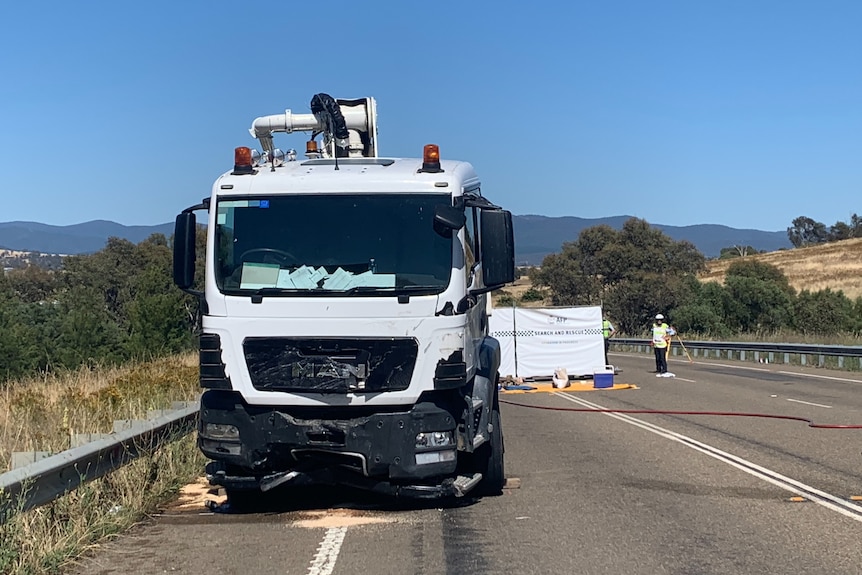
69, 354, 862, 575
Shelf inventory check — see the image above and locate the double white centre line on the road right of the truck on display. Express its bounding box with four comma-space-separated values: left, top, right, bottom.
554, 393, 862, 522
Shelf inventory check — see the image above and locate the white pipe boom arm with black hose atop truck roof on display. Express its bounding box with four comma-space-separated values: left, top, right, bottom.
249, 94, 377, 158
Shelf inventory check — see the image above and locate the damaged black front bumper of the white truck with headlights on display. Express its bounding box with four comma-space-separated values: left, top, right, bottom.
198, 390, 481, 498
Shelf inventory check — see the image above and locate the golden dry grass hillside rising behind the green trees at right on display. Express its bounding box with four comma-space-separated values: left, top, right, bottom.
700, 238, 862, 299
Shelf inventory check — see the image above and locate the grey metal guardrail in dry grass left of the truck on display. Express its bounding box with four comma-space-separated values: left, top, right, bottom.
0, 402, 200, 524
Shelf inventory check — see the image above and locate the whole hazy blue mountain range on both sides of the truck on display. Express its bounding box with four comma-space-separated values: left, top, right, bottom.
0, 215, 792, 265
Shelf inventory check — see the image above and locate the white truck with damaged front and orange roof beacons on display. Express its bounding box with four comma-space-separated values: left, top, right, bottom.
174, 94, 514, 502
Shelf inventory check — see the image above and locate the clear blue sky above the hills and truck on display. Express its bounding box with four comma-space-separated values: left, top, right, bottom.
0, 0, 862, 231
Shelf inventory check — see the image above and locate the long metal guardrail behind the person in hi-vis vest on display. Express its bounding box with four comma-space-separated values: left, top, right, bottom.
611, 337, 862, 369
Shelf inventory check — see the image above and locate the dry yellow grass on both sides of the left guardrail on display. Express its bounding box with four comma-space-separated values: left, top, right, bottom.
0, 354, 205, 575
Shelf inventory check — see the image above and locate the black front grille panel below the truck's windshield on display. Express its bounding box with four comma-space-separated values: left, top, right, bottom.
243, 337, 419, 393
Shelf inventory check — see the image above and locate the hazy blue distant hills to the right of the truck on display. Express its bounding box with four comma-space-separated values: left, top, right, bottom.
512, 215, 793, 265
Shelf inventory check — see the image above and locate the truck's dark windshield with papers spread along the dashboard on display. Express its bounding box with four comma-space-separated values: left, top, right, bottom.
216, 194, 452, 295
